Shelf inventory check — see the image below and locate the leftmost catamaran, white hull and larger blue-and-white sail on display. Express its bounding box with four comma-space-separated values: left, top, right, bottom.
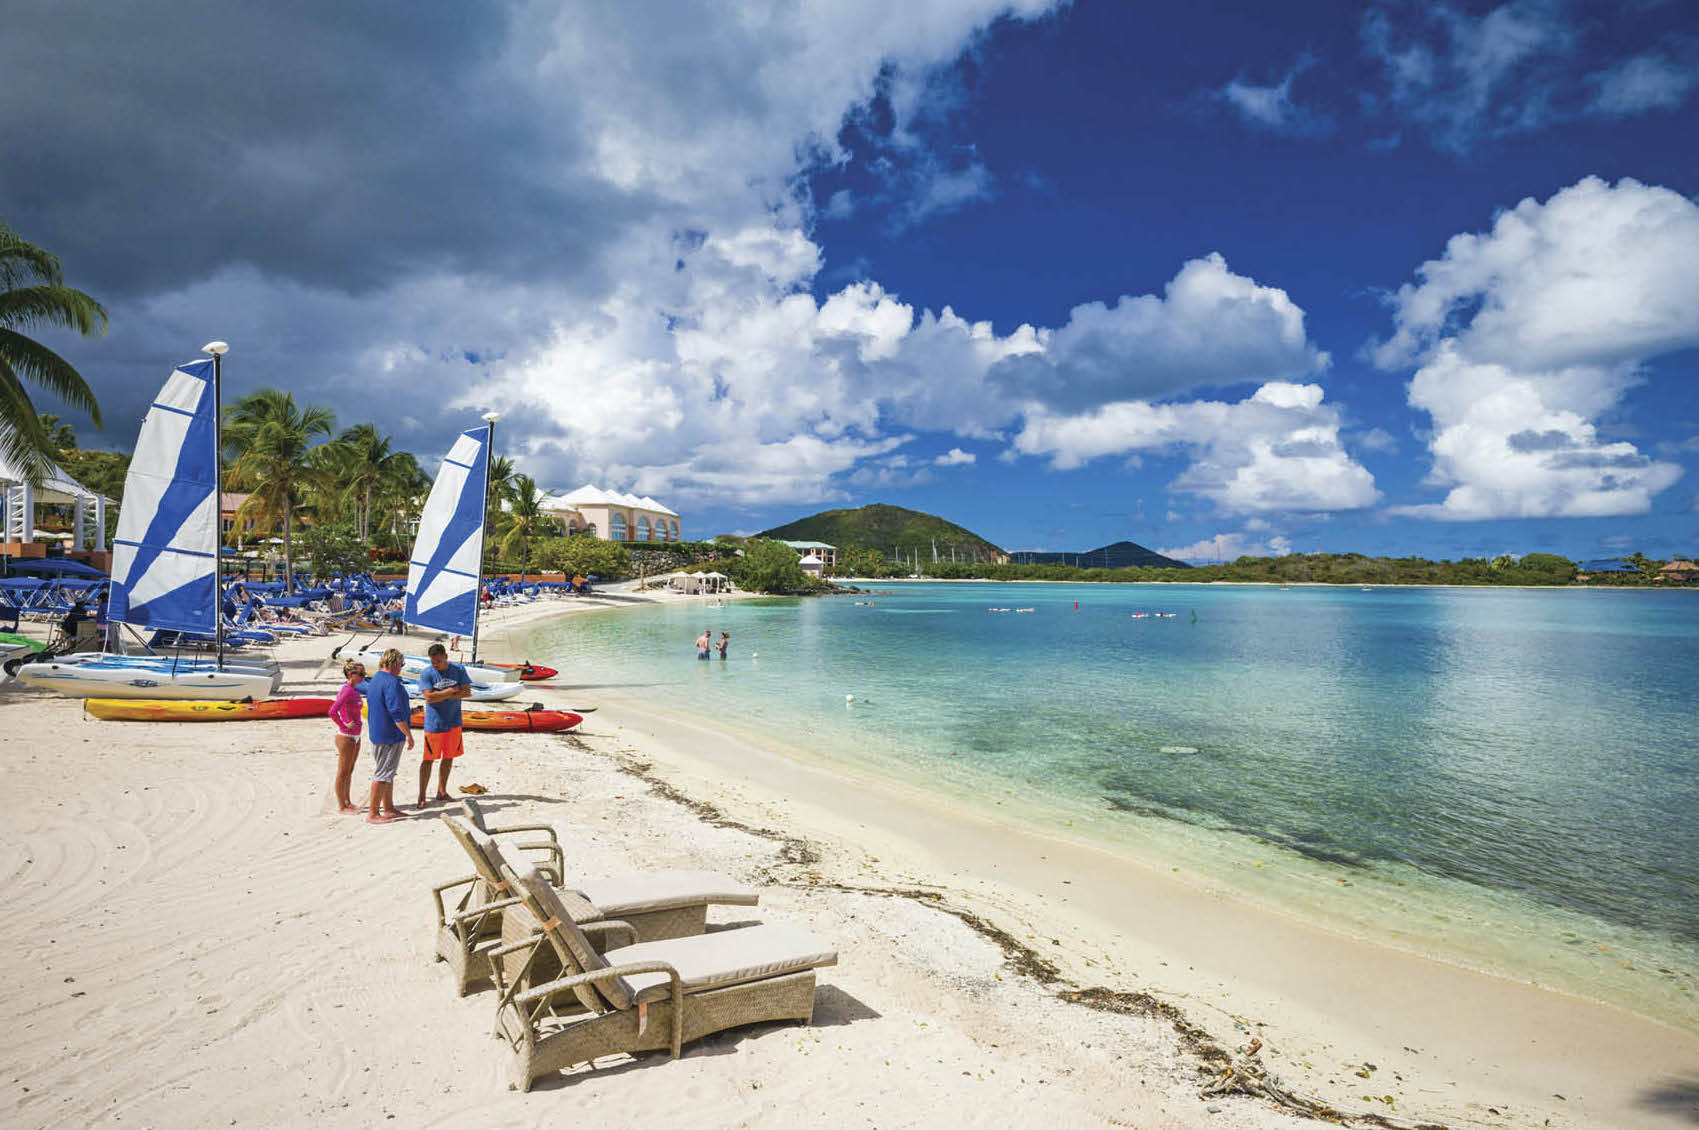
17, 342, 282, 700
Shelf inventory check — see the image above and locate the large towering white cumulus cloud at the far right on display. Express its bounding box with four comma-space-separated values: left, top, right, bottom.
1373, 177, 1699, 518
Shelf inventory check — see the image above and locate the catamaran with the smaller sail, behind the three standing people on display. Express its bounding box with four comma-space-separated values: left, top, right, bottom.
355, 413, 525, 702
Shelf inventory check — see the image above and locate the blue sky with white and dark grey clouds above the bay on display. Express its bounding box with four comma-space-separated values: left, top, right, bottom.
0, 0, 1699, 559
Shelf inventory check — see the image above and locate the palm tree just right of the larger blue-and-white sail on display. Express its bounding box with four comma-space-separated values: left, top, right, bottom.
224, 389, 336, 590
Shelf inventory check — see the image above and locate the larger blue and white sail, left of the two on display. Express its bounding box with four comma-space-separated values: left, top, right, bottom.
107, 359, 219, 634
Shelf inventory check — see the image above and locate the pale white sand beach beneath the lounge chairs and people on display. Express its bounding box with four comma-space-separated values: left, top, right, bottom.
0, 596, 1699, 1127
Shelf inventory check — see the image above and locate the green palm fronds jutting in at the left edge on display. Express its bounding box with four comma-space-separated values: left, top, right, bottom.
0, 223, 107, 484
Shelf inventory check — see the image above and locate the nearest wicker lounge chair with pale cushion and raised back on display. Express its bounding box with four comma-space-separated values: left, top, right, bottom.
491, 848, 838, 1091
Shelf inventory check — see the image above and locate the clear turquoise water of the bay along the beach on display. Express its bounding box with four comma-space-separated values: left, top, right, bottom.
532, 585, 1699, 1020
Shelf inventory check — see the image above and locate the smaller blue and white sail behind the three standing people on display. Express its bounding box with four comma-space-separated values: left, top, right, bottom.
406, 428, 489, 636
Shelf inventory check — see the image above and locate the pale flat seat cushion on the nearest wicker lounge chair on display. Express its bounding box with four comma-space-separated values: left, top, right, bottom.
618, 923, 838, 1004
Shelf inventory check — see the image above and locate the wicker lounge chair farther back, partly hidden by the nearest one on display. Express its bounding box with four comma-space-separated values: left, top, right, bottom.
432, 812, 761, 996
